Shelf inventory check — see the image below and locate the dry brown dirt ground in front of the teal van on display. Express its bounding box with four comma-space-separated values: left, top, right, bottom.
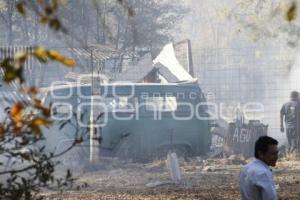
43, 158, 300, 200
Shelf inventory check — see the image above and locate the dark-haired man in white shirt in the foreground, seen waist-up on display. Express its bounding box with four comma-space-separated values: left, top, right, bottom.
240, 136, 278, 200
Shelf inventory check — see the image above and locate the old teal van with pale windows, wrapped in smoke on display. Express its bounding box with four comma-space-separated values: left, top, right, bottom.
44, 82, 211, 160
